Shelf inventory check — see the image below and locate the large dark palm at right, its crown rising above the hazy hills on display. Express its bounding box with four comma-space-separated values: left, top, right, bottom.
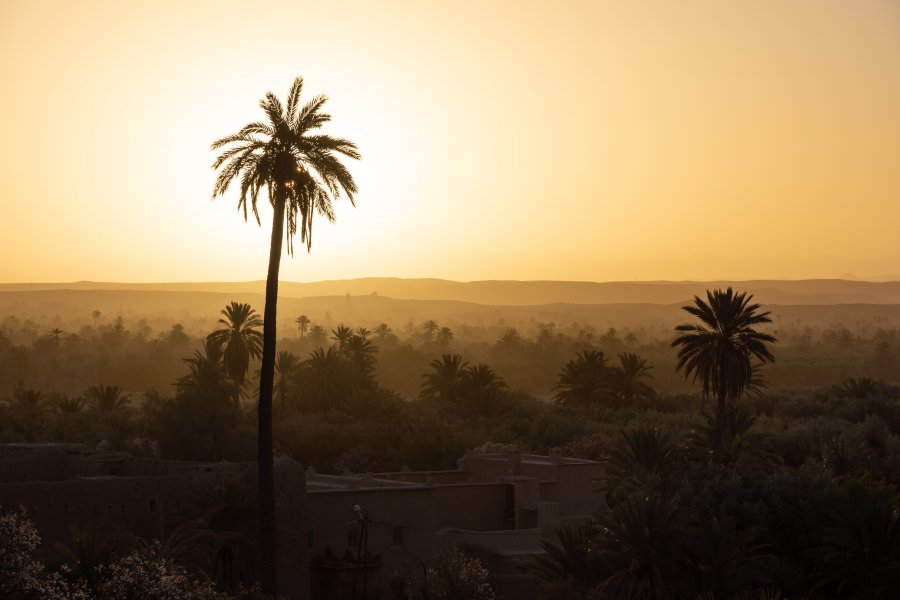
672, 287, 776, 450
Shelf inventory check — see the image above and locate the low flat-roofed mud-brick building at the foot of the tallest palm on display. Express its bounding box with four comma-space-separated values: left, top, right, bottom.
0, 444, 605, 600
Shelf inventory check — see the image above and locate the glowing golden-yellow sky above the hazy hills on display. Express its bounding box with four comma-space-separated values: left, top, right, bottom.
0, 0, 900, 282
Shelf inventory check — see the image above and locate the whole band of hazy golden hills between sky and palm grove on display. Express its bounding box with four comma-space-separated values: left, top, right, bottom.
0, 278, 900, 331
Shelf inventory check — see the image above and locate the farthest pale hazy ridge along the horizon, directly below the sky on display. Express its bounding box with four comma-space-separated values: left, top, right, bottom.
0, 277, 900, 306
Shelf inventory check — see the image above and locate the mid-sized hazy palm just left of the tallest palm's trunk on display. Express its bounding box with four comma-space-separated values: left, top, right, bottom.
206, 302, 263, 390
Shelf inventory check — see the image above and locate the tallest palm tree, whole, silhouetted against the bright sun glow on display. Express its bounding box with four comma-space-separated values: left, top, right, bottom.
212, 77, 359, 595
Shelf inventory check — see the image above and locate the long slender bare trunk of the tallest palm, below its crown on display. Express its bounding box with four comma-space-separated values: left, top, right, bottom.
256, 193, 285, 597
